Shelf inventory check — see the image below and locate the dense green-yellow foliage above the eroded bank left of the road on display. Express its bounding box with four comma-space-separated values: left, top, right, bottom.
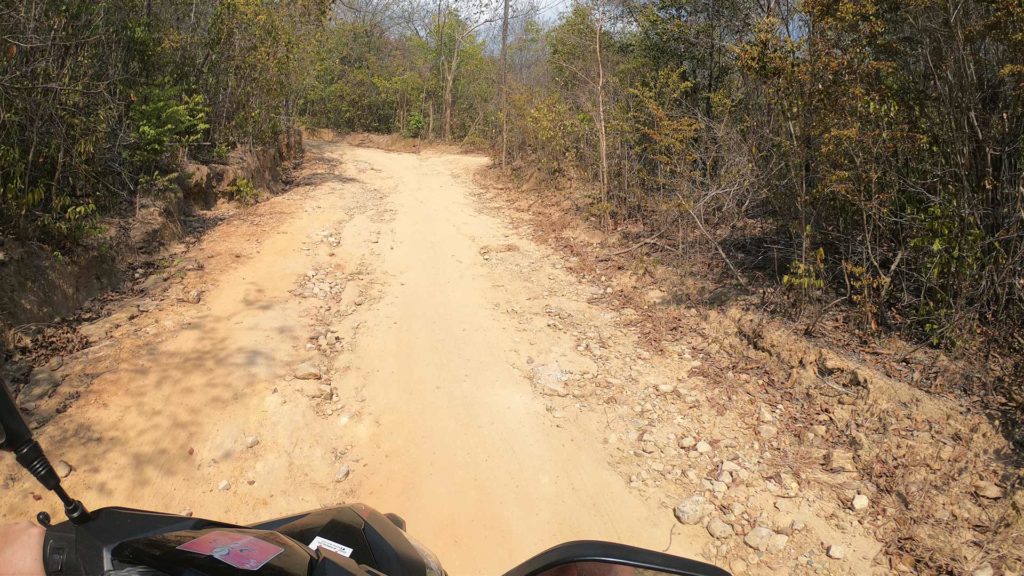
0, 0, 330, 244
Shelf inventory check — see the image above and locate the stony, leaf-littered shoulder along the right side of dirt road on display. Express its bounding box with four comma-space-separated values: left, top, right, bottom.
471, 175, 1024, 576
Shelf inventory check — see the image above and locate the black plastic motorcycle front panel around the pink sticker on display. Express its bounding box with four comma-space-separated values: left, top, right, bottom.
43, 504, 426, 576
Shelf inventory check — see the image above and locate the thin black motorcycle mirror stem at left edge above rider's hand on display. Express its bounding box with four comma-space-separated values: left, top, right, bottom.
0, 375, 90, 524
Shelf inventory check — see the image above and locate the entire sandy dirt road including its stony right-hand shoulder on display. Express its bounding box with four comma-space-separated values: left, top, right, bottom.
0, 142, 1009, 575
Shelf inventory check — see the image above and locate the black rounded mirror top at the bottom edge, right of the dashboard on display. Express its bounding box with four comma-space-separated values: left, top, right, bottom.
505, 540, 730, 576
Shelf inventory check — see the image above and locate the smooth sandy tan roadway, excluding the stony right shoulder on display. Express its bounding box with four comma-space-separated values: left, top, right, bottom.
0, 142, 741, 575
